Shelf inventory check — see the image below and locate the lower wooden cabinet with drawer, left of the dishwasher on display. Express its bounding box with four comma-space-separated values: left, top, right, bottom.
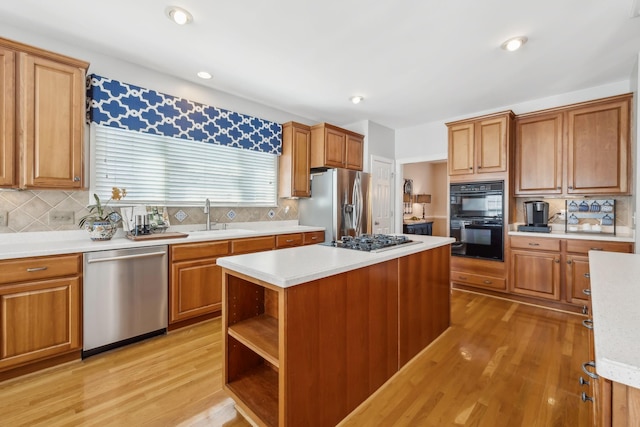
0, 254, 82, 371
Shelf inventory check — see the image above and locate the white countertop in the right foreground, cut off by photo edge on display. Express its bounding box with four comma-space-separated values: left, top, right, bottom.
589, 251, 640, 388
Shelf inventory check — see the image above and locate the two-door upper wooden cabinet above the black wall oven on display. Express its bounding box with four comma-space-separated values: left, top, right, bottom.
447, 111, 514, 180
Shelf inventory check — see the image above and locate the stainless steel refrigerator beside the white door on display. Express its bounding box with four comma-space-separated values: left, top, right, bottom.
298, 169, 371, 243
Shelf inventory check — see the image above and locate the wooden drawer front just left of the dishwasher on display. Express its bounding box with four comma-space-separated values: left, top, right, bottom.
0, 254, 82, 284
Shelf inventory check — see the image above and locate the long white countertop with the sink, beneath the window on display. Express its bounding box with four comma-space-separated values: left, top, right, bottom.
0, 221, 324, 260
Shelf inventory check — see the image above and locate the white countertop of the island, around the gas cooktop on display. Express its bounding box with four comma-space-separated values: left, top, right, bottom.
217, 234, 455, 288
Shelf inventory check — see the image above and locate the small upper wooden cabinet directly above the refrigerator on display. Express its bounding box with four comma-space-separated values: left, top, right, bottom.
311, 123, 364, 171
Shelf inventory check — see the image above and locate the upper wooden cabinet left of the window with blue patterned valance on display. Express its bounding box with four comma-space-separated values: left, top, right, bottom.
0, 39, 88, 189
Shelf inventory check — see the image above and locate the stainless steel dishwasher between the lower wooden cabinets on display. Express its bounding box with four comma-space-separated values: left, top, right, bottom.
82, 245, 168, 358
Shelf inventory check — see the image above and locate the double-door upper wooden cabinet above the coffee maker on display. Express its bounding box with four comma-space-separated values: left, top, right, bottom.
514, 95, 631, 195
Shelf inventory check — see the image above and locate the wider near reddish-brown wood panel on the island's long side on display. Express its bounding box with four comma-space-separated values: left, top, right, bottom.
284, 260, 398, 426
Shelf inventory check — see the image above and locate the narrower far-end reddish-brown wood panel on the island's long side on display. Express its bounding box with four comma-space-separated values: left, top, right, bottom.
398, 246, 451, 367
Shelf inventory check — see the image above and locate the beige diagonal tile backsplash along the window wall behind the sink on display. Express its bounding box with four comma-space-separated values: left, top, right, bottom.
0, 190, 298, 233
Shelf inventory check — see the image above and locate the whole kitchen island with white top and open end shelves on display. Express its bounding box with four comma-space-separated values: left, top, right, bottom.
218, 236, 453, 426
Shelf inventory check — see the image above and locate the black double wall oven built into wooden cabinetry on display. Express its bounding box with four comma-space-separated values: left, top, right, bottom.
449, 181, 504, 261
